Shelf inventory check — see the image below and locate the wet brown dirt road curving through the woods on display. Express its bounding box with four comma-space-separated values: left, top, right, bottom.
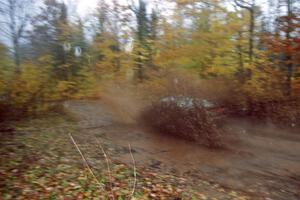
65, 101, 300, 200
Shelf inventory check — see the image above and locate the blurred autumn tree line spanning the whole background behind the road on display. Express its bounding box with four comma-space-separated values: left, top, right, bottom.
0, 0, 300, 119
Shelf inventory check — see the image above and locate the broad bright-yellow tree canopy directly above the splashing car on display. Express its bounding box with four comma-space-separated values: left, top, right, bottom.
155, 1, 246, 78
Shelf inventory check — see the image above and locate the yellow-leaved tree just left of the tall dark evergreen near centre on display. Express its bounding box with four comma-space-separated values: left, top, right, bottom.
91, 1, 131, 76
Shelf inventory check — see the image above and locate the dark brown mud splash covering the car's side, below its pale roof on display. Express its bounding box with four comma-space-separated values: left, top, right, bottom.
141, 102, 223, 148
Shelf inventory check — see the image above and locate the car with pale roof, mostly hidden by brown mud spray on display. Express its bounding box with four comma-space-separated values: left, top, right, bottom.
141, 96, 223, 148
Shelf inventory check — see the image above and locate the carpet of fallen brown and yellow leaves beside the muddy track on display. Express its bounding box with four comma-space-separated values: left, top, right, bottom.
0, 114, 252, 200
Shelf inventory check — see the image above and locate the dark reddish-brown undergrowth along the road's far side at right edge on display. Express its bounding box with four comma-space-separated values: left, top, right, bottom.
221, 92, 300, 128
